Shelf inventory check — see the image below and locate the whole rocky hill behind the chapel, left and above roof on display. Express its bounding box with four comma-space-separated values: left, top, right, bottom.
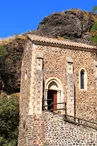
0, 9, 97, 93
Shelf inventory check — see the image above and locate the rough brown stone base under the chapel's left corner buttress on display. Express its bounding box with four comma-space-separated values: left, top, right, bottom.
18, 115, 44, 146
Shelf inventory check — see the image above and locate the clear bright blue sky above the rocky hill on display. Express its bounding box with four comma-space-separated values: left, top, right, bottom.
0, 0, 97, 38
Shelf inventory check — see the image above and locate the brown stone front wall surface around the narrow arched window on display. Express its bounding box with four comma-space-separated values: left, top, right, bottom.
37, 45, 97, 121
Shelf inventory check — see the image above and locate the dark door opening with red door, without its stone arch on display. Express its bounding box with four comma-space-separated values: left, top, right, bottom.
47, 90, 57, 111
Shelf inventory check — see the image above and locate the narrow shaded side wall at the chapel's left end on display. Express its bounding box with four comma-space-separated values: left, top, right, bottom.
18, 41, 32, 146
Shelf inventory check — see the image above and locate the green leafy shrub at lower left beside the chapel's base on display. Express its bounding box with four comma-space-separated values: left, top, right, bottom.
0, 94, 19, 146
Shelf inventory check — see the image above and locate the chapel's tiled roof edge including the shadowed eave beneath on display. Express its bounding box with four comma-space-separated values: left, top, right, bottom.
27, 34, 97, 51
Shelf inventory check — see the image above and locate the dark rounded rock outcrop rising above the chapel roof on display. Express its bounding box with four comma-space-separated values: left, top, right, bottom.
32, 9, 97, 44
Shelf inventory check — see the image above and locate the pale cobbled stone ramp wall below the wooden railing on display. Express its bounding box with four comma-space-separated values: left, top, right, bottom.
44, 112, 97, 146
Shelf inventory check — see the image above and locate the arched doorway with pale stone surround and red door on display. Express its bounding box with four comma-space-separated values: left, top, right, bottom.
44, 78, 64, 111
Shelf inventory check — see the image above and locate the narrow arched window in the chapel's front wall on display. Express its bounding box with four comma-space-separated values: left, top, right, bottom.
80, 69, 87, 90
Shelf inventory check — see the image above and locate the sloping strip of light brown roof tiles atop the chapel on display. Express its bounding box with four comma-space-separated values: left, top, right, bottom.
27, 34, 97, 50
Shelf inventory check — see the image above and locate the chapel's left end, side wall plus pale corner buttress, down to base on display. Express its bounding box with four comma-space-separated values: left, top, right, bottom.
18, 41, 44, 146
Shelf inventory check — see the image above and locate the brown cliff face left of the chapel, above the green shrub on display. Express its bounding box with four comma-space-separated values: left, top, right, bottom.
0, 37, 26, 93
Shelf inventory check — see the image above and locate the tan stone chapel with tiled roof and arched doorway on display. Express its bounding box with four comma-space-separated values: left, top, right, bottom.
18, 34, 97, 146
